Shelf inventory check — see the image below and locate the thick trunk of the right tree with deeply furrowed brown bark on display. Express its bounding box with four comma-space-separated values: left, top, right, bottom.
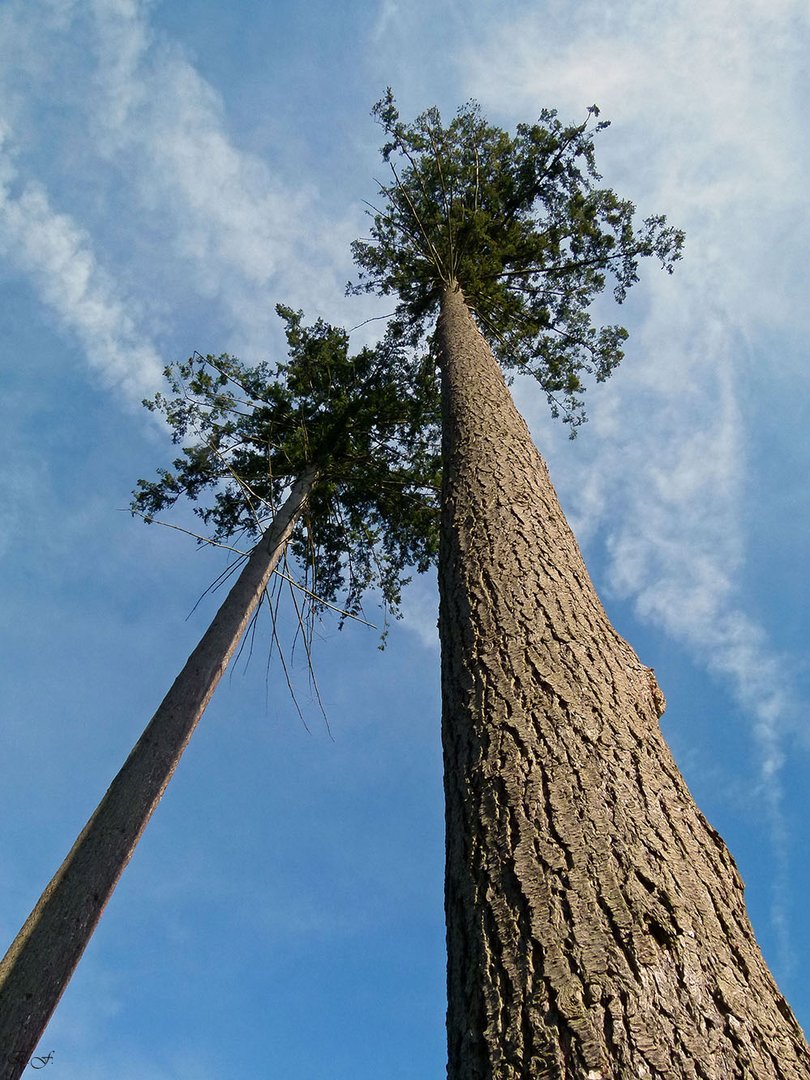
438, 289, 810, 1080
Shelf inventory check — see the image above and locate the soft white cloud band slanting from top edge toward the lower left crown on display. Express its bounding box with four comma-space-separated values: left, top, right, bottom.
85, 0, 352, 348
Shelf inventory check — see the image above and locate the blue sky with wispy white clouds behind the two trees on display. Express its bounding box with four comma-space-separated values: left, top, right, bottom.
0, 0, 810, 1080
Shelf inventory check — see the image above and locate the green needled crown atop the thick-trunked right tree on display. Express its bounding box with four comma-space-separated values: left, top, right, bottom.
350, 89, 684, 427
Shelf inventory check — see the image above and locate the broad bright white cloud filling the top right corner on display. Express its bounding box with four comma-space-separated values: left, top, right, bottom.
461, 0, 807, 325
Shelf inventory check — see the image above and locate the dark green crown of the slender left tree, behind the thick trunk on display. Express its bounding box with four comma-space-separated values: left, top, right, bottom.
132, 307, 440, 630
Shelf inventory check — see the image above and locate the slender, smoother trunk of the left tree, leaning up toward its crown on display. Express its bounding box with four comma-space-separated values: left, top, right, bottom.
0, 470, 316, 1080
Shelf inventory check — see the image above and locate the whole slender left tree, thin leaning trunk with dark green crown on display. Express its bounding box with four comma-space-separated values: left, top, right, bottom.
0, 309, 438, 1080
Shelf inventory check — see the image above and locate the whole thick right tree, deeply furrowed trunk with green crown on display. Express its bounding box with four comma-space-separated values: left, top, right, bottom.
354, 91, 810, 1080
